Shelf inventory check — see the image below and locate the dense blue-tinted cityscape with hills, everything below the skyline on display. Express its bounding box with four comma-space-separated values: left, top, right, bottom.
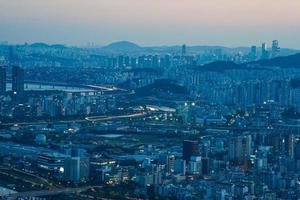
0, 40, 300, 200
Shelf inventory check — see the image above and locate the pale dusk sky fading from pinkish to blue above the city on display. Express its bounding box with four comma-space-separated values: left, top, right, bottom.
0, 0, 300, 49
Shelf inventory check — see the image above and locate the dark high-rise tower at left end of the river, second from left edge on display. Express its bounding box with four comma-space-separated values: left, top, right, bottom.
12, 65, 24, 96
